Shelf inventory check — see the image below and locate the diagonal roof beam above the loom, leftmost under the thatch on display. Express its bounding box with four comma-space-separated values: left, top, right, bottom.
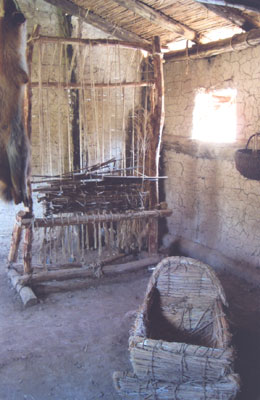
44, 0, 149, 45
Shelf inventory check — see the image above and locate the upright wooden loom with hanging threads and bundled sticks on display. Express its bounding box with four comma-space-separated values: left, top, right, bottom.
9, 32, 170, 304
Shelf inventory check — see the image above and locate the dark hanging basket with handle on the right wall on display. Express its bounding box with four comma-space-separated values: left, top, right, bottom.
235, 133, 260, 181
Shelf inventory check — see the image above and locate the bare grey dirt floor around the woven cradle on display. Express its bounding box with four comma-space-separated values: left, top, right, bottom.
0, 241, 260, 400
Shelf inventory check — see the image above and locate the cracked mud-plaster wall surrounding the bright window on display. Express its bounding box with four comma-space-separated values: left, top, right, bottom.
163, 46, 260, 276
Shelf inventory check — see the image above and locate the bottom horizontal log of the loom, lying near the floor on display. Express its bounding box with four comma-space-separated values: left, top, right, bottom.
18, 254, 161, 285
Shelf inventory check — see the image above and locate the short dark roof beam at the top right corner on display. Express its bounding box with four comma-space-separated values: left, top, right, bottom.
202, 3, 259, 32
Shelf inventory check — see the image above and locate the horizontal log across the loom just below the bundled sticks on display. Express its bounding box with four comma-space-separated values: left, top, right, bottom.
18, 210, 172, 228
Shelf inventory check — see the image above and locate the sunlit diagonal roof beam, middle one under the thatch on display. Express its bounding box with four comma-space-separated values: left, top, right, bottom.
113, 0, 199, 42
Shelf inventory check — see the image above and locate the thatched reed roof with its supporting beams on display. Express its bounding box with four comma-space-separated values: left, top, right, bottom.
46, 0, 260, 50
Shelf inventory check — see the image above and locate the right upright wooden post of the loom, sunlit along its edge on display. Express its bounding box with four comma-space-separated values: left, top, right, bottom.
149, 36, 165, 253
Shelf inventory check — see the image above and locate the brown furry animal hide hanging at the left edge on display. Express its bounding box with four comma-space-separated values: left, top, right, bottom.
0, 0, 30, 205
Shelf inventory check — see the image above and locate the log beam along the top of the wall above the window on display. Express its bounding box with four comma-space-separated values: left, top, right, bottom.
164, 29, 260, 61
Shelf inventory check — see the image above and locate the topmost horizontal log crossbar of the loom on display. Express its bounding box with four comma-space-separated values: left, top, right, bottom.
34, 36, 152, 53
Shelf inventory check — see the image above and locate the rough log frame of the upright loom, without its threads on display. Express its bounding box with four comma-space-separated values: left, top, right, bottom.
8, 34, 171, 306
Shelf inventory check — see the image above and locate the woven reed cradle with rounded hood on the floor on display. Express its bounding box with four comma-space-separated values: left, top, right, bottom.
113, 257, 239, 400
